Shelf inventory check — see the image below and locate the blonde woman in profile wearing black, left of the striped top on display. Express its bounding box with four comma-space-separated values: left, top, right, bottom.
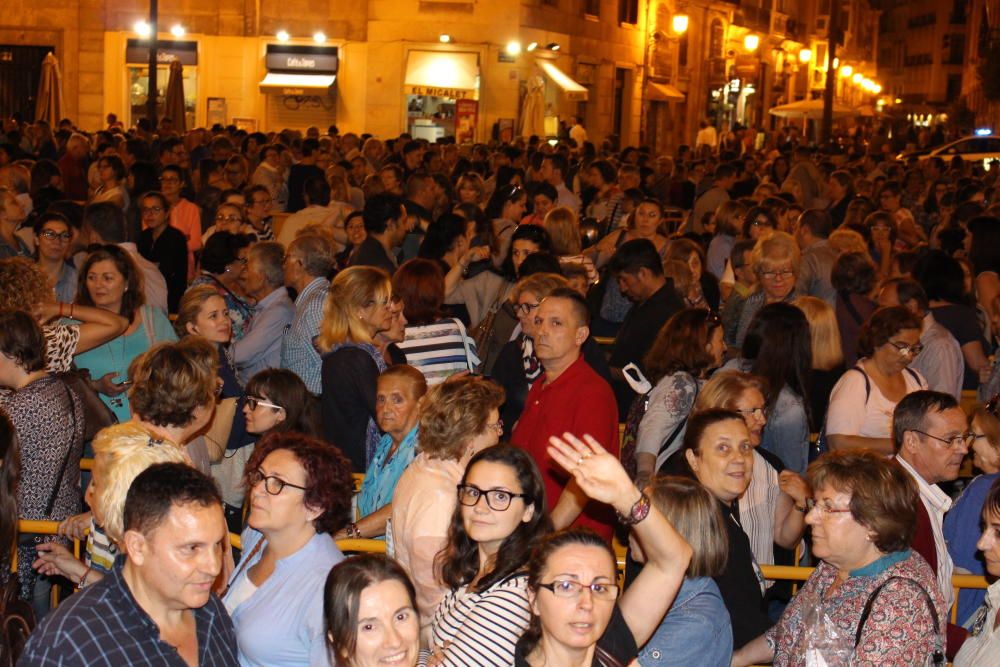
317, 266, 392, 472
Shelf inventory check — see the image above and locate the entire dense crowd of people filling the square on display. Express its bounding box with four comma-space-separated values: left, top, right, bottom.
0, 112, 1000, 667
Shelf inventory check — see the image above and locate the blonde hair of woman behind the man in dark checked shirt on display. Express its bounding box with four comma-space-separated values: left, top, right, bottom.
91, 421, 187, 542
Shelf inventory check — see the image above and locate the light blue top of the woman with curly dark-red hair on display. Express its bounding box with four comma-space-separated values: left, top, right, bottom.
223, 528, 344, 667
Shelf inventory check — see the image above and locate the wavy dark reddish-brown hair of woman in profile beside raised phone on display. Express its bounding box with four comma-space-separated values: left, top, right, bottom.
644, 308, 722, 385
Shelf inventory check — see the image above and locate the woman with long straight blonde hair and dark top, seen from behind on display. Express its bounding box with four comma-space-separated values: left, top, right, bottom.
792, 296, 846, 433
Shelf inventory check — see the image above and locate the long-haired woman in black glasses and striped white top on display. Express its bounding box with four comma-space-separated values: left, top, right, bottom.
427, 445, 552, 667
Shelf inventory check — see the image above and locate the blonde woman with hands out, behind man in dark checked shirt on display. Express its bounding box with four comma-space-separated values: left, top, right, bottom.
31, 422, 188, 588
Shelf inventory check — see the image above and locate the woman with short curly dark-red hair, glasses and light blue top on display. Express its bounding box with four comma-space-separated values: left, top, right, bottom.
222, 430, 352, 666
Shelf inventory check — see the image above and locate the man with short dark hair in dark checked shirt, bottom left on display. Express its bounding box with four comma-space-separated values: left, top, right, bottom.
18, 463, 239, 667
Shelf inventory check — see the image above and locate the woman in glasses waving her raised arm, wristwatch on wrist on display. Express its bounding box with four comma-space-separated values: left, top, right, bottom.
508, 434, 692, 667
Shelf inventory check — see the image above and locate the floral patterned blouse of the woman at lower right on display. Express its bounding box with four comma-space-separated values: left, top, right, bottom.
765, 549, 948, 667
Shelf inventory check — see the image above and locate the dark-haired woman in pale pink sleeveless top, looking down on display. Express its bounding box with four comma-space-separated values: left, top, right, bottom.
824, 306, 927, 456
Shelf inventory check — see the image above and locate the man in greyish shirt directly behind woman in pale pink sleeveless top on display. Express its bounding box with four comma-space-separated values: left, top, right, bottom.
878, 278, 965, 400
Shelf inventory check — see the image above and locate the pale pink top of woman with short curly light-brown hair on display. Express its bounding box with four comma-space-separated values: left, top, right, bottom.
392, 454, 464, 643
